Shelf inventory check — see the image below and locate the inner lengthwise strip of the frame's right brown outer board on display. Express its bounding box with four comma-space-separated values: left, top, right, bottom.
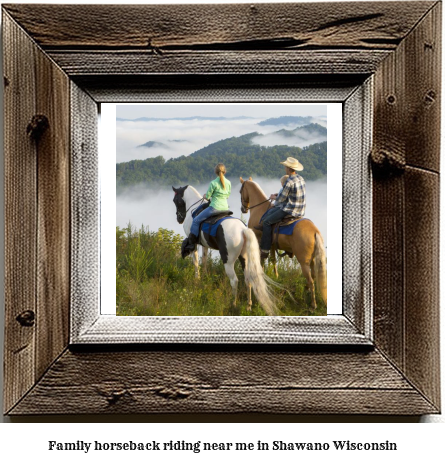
372, 44, 406, 369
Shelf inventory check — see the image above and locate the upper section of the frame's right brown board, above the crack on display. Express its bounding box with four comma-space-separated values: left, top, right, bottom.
374, 3, 441, 172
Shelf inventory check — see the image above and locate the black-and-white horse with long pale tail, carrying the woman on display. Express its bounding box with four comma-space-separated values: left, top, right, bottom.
173, 186, 275, 315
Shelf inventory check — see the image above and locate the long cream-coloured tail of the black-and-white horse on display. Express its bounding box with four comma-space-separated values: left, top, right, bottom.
243, 228, 276, 315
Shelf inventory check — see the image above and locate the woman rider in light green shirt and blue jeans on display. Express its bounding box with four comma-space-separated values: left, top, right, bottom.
182, 163, 232, 258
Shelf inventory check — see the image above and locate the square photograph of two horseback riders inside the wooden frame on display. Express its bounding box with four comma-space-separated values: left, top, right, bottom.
116, 104, 328, 316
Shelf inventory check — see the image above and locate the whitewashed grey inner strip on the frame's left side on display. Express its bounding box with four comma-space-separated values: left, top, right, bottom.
70, 82, 100, 340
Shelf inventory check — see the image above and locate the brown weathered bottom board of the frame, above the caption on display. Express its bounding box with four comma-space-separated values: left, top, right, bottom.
11, 351, 435, 415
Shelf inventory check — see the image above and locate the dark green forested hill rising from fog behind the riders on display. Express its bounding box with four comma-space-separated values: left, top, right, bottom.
116, 133, 327, 193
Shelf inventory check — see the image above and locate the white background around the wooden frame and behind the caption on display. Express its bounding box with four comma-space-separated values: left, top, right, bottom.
0, 0, 445, 464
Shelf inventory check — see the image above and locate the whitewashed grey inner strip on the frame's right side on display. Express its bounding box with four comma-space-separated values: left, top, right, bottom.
342, 78, 373, 339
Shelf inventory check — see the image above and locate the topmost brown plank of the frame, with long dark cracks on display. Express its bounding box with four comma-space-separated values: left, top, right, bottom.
5, 1, 434, 49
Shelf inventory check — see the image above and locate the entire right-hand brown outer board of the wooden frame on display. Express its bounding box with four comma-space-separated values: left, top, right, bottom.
373, 4, 441, 405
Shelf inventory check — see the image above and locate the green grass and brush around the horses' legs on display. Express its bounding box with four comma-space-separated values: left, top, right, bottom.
116, 224, 326, 316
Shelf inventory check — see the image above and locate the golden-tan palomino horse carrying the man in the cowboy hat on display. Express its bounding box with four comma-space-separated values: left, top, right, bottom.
240, 178, 327, 308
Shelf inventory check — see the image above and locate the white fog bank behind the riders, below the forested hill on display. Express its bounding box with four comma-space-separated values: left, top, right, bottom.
116, 177, 327, 247
